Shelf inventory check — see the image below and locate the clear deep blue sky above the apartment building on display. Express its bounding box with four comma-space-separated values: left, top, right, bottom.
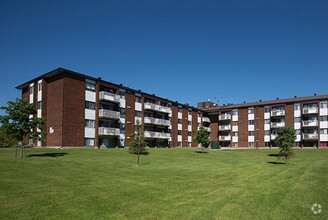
0, 0, 328, 111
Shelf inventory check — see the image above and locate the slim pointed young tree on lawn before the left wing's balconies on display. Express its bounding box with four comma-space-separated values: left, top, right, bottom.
129, 120, 148, 167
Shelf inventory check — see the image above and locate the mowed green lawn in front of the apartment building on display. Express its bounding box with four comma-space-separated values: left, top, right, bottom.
0, 148, 328, 219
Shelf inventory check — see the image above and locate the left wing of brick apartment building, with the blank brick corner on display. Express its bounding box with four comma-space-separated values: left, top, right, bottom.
17, 68, 210, 147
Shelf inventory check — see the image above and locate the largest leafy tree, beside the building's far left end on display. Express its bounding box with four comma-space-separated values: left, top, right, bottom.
0, 99, 45, 157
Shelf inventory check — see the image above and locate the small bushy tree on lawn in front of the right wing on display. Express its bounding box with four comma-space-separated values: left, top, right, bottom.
274, 127, 296, 164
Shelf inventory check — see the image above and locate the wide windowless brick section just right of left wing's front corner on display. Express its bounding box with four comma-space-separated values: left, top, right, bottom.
63, 75, 85, 147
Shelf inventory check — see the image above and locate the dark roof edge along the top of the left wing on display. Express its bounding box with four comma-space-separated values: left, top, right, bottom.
16, 67, 203, 111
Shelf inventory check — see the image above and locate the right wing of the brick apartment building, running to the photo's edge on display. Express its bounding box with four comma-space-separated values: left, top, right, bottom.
198, 94, 328, 148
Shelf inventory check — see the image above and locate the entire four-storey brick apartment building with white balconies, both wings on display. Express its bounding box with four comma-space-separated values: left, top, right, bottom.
17, 68, 328, 147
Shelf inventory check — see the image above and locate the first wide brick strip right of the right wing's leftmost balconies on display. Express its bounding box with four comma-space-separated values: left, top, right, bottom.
238, 108, 248, 147
